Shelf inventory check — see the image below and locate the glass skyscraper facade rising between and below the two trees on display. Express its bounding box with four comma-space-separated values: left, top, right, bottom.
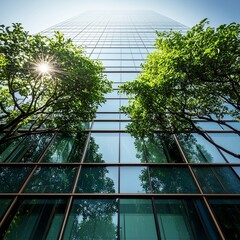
0, 11, 240, 240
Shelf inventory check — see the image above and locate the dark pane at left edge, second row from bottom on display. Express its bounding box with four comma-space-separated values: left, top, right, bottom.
0, 166, 31, 193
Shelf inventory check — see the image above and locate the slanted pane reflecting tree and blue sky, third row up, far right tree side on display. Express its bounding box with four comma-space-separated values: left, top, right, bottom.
178, 134, 226, 163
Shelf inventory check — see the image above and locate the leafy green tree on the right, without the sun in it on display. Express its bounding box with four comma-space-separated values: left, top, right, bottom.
121, 19, 240, 157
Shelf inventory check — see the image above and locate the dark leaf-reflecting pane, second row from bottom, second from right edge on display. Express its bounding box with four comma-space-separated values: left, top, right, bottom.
150, 167, 199, 193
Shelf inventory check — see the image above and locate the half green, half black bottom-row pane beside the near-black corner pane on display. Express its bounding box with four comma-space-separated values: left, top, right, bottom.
155, 199, 220, 240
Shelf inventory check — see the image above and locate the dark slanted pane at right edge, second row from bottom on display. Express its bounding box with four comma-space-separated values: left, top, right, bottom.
193, 166, 240, 193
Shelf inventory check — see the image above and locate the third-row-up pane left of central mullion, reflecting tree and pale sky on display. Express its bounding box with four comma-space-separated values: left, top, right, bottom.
84, 133, 119, 163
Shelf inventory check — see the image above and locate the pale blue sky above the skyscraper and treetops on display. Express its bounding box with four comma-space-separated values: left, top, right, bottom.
0, 0, 240, 33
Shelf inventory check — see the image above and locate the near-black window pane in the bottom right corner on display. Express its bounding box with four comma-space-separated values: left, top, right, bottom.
209, 199, 240, 240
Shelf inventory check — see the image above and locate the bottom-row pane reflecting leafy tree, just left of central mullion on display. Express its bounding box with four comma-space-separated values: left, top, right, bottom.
63, 199, 118, 240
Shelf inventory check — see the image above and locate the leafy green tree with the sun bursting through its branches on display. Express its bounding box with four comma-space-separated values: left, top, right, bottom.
0, 23, 111, 141
